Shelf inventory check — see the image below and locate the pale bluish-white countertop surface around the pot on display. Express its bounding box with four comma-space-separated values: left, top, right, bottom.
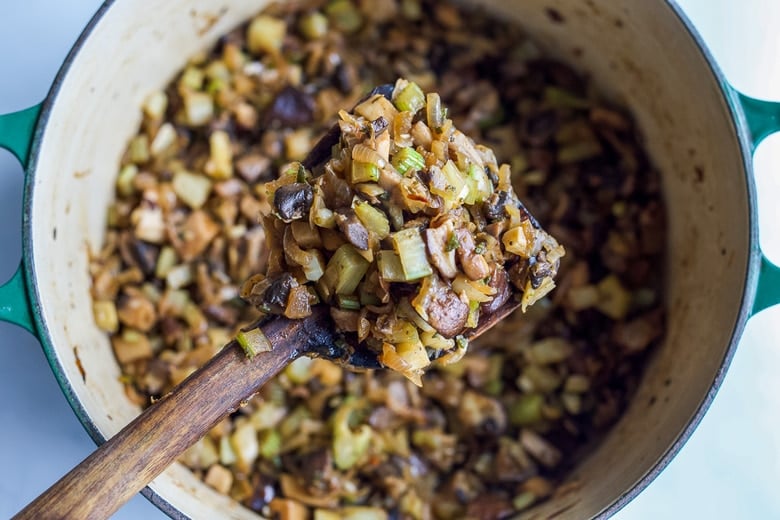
0, 0, 780, 520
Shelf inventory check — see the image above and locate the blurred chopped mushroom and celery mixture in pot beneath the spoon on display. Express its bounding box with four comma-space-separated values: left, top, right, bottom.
90, 0, 665, 519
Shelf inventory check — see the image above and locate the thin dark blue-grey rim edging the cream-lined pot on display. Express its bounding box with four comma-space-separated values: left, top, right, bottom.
22, 0, 761, 520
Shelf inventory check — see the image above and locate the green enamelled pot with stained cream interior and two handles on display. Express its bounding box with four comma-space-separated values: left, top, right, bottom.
0, 0, 780, 518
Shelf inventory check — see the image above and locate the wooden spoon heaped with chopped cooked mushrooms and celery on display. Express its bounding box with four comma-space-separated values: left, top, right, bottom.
17, 79, 564, 518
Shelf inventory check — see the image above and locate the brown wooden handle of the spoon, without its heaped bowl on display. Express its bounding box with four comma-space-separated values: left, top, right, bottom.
14, 314, 333, 520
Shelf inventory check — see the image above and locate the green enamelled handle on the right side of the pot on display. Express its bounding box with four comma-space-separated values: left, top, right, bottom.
737, 92, 780, 314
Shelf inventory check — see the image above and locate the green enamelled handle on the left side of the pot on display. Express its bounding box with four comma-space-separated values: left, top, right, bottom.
0, 105, 41, 334
